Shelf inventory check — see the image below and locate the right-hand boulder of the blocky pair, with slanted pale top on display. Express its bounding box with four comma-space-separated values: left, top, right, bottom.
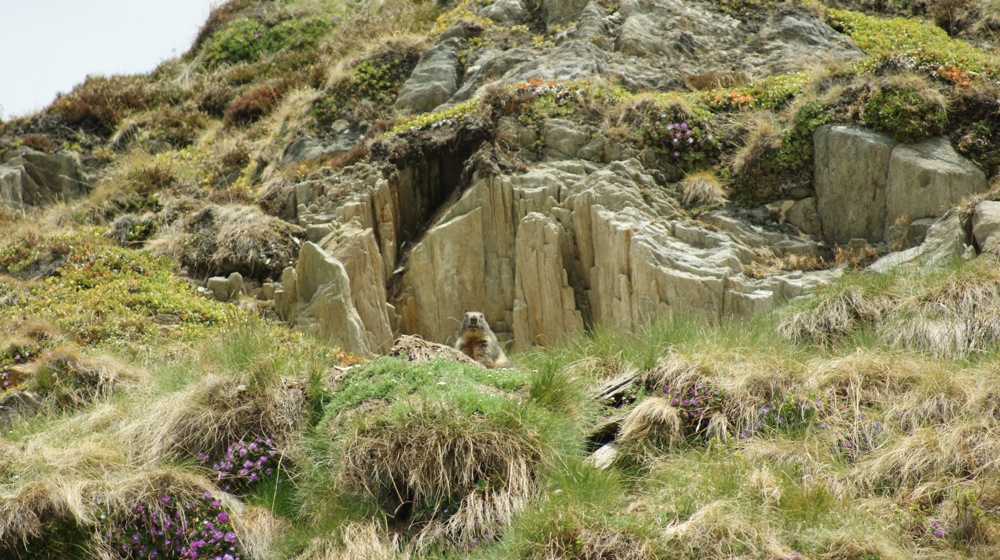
885, 138, 987, 240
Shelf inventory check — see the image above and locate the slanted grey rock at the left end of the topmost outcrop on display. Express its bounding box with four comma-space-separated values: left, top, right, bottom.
396, 39, 461, 113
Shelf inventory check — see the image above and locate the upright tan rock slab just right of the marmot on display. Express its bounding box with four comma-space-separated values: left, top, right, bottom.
512, 212, 583, 347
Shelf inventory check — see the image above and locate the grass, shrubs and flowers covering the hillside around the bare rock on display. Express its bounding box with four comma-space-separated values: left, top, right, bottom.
0, 0, 1000, 560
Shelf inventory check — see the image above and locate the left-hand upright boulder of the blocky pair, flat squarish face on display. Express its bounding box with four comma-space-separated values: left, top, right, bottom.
813, 125, 893, 244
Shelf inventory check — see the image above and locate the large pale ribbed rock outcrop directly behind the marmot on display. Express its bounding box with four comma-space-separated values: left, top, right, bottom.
386, 160, 834, 345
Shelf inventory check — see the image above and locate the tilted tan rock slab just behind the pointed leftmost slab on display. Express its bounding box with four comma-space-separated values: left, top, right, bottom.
319, 220, 395, 353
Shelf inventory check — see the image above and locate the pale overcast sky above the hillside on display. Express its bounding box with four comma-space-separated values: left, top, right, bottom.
0, 0, 222, 119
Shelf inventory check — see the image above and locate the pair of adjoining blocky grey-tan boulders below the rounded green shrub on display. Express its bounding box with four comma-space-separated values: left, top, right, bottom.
814, 125, 987, 244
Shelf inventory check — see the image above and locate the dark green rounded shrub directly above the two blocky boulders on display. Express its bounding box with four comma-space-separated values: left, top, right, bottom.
864, 87, 948, 142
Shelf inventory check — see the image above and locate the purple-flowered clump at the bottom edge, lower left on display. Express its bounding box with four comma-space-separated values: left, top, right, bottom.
100, 491, 240, 560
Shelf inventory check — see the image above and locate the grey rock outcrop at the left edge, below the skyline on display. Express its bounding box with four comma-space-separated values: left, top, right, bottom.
0, 148, 90, 208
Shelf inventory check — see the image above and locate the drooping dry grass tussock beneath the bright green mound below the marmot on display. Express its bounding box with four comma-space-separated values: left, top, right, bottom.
340, 403, 543, 541
